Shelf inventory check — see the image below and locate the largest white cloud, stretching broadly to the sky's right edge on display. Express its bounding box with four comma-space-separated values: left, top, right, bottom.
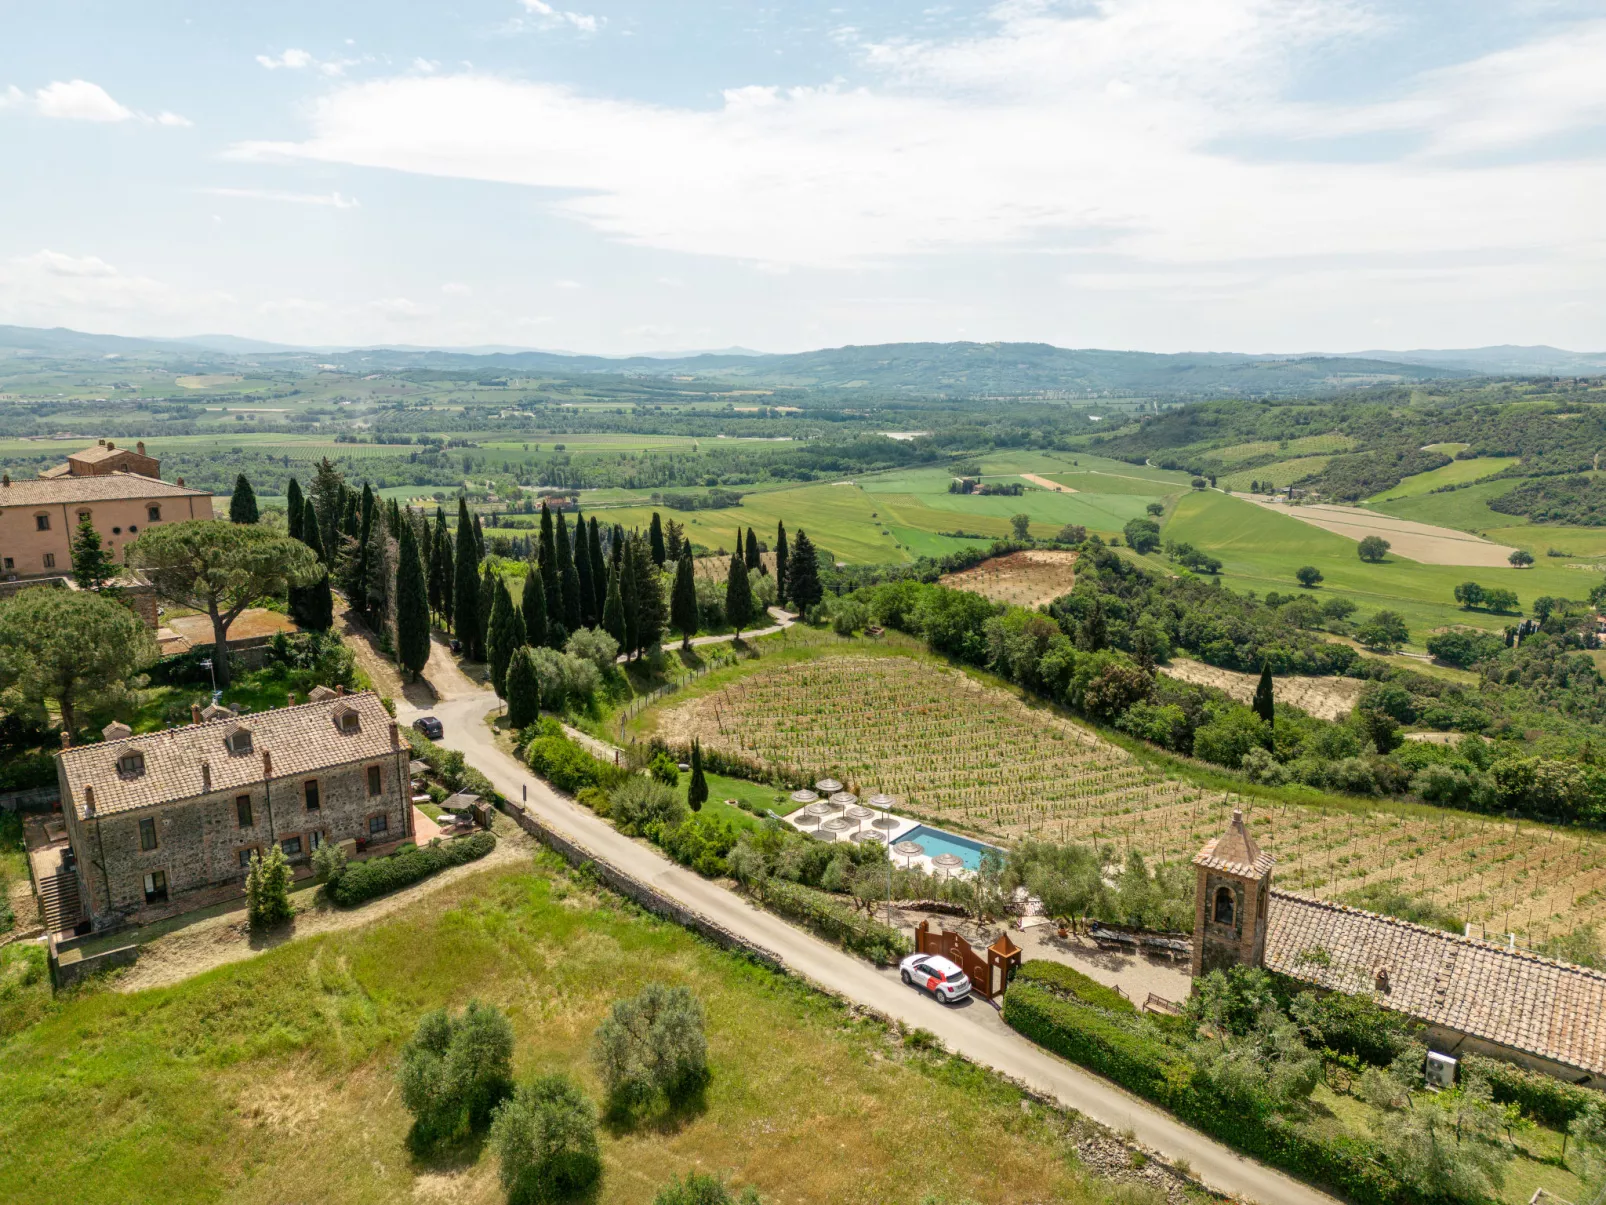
223, 0, 1606, 306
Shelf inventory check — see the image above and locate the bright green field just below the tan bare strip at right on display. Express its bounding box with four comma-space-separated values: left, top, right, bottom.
1164, 487, 1596, 649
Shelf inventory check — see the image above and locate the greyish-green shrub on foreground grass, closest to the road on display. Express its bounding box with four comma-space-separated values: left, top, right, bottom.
591, 983, 708, 1109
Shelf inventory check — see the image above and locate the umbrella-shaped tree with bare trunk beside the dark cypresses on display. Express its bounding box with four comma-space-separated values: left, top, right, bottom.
127, 519, 323, 686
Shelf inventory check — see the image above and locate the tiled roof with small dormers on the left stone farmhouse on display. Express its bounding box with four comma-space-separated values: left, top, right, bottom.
56, 691, 398, 818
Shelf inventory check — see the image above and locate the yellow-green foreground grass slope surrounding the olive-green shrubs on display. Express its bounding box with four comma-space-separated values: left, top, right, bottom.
0, 855, 1105, 1205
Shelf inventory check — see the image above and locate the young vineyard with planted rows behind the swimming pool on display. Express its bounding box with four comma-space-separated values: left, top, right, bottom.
657, 652, 1606, 945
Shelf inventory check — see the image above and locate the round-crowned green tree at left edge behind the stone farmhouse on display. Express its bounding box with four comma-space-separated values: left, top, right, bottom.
0, 586, 157, 733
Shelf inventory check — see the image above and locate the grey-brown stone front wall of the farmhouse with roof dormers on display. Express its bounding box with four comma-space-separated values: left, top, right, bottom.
64, 745, 413, 929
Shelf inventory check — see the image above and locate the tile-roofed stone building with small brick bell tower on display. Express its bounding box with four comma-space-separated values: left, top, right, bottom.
1192, 811, 1606, 1089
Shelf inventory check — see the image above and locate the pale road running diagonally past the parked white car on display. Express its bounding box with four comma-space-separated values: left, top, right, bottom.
397, 691, 1335, 1205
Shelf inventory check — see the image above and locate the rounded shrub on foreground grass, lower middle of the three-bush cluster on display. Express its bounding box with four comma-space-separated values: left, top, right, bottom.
490, 1075, 602, 1205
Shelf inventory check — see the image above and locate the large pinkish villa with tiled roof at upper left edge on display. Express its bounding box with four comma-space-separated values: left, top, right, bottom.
0, 440, 214, 584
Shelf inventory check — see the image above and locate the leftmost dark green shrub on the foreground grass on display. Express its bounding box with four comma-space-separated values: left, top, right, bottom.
397, 1001, 512, 1150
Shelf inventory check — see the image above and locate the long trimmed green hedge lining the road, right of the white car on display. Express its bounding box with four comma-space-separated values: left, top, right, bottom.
1004, 967, 1441, 1205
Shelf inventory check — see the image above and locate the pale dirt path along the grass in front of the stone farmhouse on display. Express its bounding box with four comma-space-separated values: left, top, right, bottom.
112, 818, 535, 991
